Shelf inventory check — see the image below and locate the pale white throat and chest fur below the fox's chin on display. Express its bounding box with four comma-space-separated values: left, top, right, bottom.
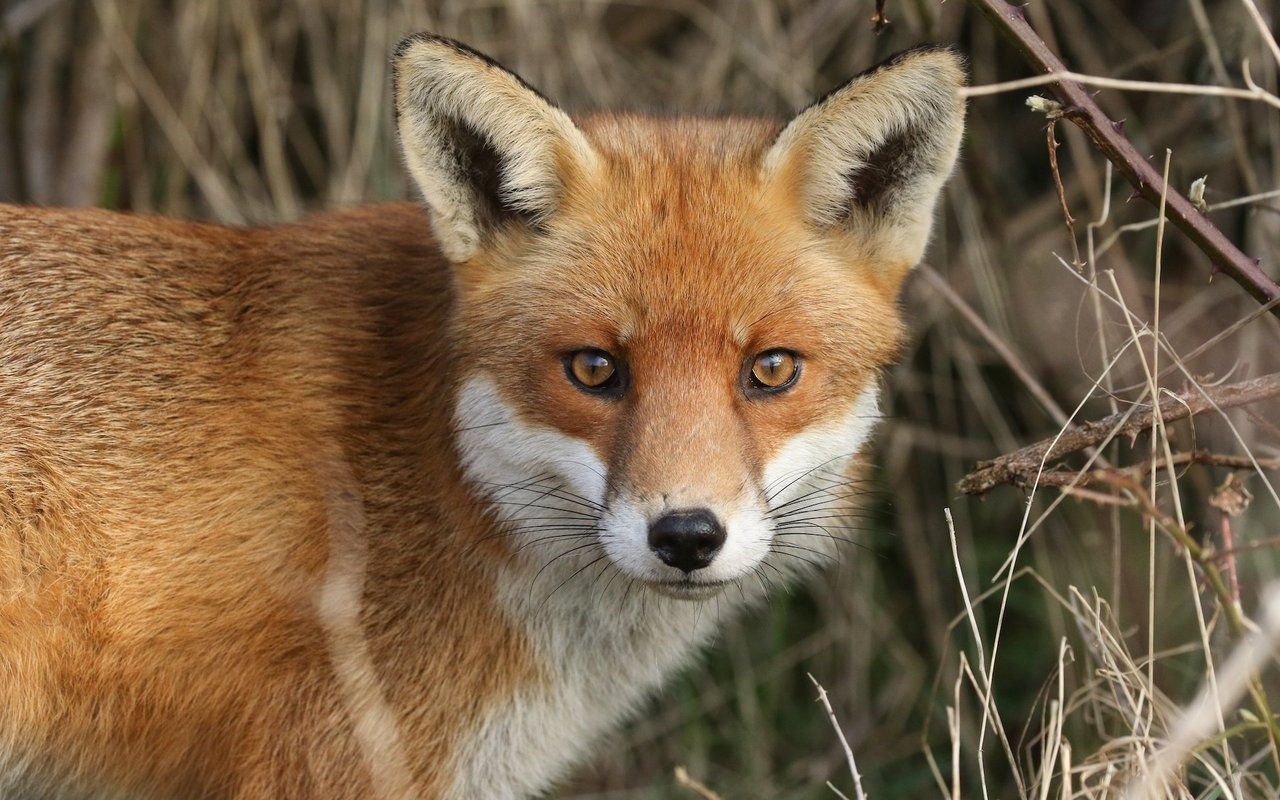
452, 559, 735, 799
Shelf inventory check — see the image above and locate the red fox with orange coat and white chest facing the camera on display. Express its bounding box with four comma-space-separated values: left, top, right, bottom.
0, 35, 964, 800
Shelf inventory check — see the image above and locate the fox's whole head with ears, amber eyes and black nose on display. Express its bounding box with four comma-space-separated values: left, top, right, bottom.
396, 35, 964, 598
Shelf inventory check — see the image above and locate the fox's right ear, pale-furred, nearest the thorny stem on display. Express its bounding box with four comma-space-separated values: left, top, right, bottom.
764, 47, 965, 278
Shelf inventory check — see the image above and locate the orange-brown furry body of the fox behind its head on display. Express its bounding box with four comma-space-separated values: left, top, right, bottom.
0, 205, 535, 797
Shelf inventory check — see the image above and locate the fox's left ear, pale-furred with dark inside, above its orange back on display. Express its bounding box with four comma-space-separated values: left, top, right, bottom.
394, 33, 595, 262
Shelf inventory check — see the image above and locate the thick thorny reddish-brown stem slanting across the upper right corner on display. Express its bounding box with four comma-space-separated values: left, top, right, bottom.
970, 0, 1280, 316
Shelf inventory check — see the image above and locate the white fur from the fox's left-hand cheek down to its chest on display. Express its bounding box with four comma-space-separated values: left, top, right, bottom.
453, 379, 756, 797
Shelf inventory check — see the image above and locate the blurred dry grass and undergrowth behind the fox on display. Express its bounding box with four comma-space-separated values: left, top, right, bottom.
0, 0, 1280, 800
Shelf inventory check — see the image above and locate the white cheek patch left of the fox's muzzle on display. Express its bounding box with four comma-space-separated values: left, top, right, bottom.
453, 376, 605, 540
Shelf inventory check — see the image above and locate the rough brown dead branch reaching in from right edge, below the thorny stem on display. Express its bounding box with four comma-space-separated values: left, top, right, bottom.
956, 372, 1280, 494
